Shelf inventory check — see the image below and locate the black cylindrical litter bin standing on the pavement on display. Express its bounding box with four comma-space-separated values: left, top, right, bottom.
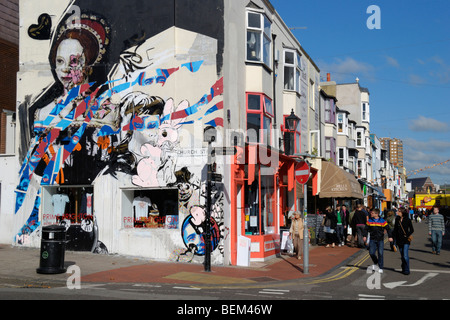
36, 225, 66, 274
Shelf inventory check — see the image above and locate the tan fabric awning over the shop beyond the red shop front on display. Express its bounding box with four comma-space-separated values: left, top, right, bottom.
319, 161, 363, 199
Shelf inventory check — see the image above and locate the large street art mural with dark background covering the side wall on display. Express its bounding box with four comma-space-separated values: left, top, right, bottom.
15, 0, 224, 262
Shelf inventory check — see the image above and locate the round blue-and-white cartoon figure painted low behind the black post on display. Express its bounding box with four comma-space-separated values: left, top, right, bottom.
181, 206, 220, 256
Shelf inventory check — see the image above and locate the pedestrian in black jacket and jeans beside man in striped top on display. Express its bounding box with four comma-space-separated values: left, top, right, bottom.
393, 207, 414, 275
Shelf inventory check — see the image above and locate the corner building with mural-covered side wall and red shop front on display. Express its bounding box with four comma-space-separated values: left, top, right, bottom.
9, 0, 320, 264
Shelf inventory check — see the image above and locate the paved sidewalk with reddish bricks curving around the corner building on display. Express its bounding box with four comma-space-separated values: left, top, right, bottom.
0, 244, 361, 286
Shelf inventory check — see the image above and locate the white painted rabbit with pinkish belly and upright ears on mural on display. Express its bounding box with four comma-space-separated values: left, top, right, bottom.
132, 99, 189, 187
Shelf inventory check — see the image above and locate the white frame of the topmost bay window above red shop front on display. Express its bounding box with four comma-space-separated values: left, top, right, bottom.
245, 10, 272, 68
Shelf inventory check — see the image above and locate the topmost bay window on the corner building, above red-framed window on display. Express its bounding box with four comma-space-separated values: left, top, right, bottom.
247, 11, 272, 67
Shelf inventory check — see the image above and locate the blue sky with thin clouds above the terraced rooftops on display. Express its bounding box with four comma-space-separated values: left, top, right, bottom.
271, 0, 450, 184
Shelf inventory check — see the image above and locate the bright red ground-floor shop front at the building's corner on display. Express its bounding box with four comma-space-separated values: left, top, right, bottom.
230, 144, 302, 265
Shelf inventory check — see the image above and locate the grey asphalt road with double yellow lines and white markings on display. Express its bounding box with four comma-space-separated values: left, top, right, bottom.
0, 222, 450, 306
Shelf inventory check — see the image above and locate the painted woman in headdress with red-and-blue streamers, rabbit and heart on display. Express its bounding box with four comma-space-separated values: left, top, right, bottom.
15, 1, 224, 255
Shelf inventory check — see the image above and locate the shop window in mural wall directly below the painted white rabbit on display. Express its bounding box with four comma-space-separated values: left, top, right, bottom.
123, 189, 179, 229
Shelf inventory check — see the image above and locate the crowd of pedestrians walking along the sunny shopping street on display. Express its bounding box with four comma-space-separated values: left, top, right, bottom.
290, 204, 445, 275
